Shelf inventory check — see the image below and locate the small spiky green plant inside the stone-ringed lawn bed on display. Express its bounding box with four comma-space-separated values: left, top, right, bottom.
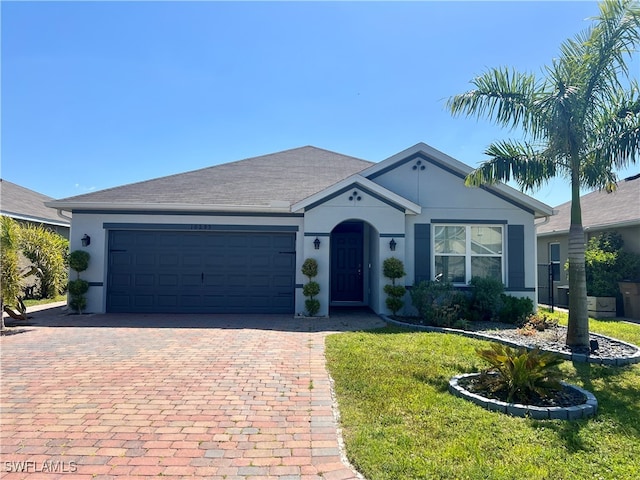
476, 343, 563, 404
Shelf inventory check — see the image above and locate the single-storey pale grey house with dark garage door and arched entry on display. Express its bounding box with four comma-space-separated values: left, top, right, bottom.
48, 144, 552, 315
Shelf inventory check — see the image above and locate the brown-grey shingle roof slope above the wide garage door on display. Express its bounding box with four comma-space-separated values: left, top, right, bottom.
56, 146, 372, 206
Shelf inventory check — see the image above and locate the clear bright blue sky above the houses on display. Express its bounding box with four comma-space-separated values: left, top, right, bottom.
1, 1, 640, 206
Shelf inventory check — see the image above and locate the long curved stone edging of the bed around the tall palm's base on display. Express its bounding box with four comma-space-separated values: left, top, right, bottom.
381, 315, 640, 366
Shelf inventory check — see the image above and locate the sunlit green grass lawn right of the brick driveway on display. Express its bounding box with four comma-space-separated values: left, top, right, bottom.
327, 315, 640, 480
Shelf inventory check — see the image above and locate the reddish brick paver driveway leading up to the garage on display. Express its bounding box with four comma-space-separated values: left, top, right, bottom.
0, 309, 382, 480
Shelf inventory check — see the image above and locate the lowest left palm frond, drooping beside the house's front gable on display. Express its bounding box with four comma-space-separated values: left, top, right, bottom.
465, 140, 558, 191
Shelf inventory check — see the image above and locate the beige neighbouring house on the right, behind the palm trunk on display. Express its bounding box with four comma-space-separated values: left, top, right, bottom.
536, 175, 640, 305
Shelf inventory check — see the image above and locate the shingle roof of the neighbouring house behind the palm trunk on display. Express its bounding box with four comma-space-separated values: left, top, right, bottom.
537, 175, 640, 235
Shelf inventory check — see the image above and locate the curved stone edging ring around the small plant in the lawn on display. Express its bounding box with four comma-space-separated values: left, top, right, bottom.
449, 373, 598, 420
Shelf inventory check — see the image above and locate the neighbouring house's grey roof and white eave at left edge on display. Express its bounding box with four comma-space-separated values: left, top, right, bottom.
0, 179, 71, 239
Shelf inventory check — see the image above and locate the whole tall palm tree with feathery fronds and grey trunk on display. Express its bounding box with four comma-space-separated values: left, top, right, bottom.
447, 0, 640, 347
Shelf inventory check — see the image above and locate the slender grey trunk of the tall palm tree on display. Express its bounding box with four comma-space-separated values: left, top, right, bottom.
566, 168, 589, 348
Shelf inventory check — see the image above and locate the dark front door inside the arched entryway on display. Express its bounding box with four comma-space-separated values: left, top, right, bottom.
331, 223, 364, 302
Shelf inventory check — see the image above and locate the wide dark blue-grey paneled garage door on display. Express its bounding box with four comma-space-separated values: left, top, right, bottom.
107, 230, 295, 313
